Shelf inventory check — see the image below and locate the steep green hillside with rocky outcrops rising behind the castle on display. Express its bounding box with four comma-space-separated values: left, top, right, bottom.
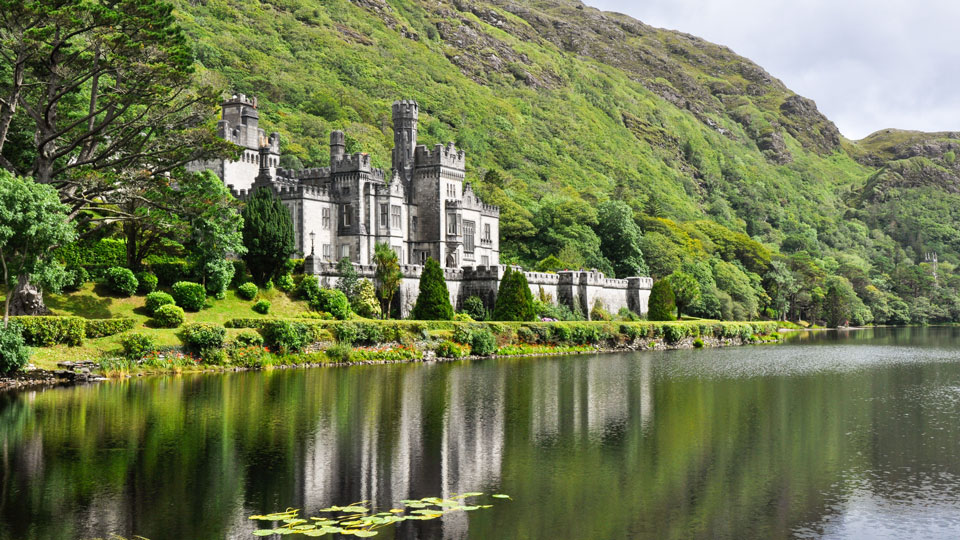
171, 0, 960, 322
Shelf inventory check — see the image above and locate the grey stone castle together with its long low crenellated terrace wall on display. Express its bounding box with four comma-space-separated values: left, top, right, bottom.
188, 95, 653, 316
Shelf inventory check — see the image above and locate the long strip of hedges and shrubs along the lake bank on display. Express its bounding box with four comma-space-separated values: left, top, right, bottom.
4, 317, 780, 387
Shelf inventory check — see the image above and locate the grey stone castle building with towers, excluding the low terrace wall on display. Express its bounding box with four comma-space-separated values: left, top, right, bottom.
190, 95, 500, 268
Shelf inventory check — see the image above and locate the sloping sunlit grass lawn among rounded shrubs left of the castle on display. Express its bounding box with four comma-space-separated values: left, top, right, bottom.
16, 283, 309, 369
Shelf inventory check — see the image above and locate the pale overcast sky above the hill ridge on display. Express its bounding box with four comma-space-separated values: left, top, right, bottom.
584, 0, 960, 139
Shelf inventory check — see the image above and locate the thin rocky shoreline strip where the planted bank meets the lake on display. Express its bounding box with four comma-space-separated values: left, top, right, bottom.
0, 329, 772, 393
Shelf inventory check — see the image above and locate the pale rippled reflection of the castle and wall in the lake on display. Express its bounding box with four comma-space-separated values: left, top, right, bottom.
292, 356, 652, 539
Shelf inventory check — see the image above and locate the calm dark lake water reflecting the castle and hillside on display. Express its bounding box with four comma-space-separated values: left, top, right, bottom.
0, 328, 960, 540
